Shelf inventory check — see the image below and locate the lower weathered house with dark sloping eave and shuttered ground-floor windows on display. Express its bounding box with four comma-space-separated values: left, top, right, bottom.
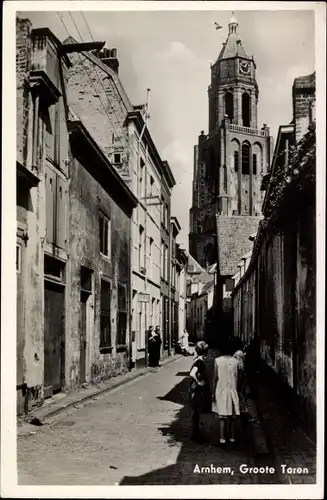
66, 120, 138, 388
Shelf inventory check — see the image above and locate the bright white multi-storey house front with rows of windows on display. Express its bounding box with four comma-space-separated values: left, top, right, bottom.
128, 110, 174, 366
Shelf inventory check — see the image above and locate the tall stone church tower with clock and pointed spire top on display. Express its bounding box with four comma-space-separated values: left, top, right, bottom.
189, 14, 273, 275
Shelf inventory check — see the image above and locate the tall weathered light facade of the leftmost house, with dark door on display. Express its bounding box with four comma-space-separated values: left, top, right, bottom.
16, 19, 70, 413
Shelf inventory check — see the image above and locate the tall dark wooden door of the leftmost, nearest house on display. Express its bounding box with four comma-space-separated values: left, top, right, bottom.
44, 281, 64, 397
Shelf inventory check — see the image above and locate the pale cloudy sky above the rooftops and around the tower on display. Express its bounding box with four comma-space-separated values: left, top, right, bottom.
19, 10, 315, 249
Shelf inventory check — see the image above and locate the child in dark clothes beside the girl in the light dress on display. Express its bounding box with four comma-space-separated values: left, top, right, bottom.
190, 341, 210, 441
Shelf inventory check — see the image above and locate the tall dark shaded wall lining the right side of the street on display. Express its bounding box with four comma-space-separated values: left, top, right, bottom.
233, 179, 316, 434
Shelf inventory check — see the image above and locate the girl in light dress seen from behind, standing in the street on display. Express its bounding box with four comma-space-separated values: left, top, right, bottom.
212, 341, 240, 444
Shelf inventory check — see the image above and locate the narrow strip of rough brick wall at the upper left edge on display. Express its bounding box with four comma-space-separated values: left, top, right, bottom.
16, 18, 32, 165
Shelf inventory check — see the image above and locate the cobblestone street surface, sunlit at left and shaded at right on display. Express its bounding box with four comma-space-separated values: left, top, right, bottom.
18, 357, 264, 485
